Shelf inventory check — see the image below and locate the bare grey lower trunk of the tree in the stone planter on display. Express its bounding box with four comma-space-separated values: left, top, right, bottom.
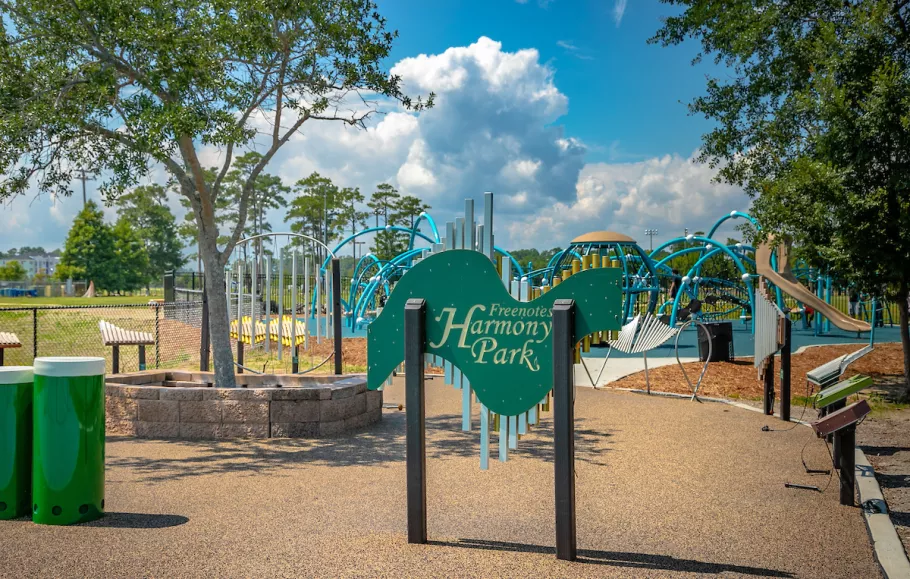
200, 239, 236, 388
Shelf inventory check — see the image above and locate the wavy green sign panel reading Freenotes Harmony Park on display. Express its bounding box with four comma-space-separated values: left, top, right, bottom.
367, 250, 622, 416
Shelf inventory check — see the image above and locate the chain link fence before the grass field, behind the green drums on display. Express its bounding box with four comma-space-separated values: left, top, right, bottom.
0, 301, 202, 372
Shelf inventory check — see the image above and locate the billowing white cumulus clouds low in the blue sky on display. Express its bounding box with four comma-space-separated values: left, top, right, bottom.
0, 37, 748, 258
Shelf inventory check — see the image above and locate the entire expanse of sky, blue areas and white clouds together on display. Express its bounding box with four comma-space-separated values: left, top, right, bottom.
0, 0, 749, 254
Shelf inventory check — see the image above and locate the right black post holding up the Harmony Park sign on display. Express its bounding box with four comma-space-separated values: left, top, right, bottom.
553, 300, 577, 561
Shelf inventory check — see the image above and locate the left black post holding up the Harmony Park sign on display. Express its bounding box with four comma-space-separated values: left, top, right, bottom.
406, 300, 427, 544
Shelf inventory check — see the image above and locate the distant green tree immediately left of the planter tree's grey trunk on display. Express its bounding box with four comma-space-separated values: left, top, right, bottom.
117, 185, 186, 288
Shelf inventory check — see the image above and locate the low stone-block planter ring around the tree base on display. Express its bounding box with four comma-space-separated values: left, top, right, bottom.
105, 370, 382, 440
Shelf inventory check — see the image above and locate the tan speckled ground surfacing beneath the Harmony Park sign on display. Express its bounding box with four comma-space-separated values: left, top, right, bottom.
0, 379, 880, 578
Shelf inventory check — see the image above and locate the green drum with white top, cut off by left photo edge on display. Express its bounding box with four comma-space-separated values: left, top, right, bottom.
0, 366, 32, 519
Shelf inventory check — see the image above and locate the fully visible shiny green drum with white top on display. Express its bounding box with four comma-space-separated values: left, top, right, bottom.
32, 358, 104, 525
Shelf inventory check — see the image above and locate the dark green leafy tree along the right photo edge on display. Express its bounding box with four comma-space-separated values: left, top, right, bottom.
652, 0, 910, 395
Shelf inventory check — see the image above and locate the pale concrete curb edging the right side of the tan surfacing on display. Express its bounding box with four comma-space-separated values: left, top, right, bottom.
612, 388, 910, 579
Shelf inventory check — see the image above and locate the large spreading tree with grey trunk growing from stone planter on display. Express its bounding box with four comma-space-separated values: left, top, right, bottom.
0, 0, 432, 387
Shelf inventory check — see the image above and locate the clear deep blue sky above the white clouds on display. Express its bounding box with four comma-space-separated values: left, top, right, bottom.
379, 0, 714, 163
